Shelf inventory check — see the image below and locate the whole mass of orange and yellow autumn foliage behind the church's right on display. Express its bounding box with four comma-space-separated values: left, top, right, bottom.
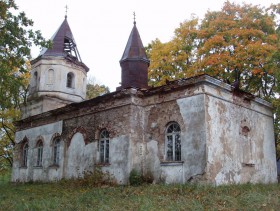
147, 1, 280, 157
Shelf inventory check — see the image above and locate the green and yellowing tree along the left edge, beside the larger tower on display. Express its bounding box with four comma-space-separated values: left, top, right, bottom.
0, 0, 50, 171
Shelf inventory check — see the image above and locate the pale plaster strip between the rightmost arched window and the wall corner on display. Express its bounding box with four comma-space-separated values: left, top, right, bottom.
177, 94, 206, 182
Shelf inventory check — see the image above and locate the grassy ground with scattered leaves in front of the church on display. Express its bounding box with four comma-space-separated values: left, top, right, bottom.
0, 178, 280, 211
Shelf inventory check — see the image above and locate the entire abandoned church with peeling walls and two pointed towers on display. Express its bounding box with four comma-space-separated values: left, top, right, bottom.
12, 17, 277, 185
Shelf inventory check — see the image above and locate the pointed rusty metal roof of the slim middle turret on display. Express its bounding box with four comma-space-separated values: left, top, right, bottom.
120, 22, 150, 63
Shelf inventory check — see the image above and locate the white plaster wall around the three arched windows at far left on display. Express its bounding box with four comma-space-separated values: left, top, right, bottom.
12, 121, 64, 182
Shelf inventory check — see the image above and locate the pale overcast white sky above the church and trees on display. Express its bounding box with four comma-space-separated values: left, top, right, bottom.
15, 0, 279, 91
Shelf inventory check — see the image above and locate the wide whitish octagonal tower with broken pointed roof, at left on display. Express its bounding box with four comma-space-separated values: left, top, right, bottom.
22, 16, 89, 118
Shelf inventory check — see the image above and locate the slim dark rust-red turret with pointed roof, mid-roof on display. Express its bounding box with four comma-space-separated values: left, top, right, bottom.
117, 17, 150, 90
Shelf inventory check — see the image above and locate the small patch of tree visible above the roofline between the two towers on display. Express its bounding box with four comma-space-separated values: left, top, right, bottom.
86, 78, 110, 100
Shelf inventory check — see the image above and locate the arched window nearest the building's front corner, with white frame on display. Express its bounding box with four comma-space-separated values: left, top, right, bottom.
165, 122, 181, 161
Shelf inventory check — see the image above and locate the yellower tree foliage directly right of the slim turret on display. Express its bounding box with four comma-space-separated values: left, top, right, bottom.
146, 18, 198, 86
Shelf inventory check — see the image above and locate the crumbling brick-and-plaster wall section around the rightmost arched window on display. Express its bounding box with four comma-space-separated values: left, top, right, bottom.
145, 86, 206, 183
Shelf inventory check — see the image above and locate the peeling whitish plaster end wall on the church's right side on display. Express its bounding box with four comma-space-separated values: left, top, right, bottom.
205, 93, 277, 185
